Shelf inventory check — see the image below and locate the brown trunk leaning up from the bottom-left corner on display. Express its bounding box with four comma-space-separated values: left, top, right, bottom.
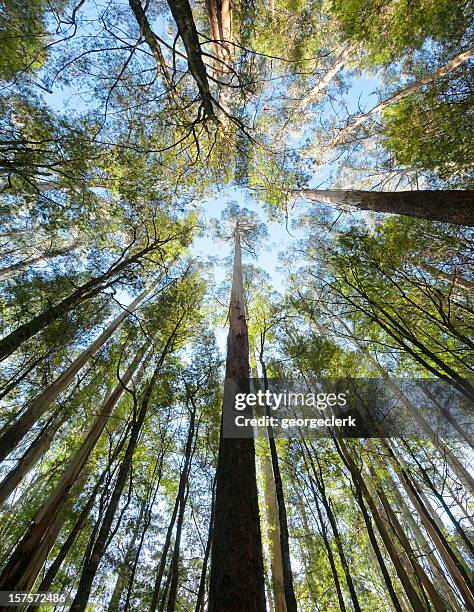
0, 341, 148, 591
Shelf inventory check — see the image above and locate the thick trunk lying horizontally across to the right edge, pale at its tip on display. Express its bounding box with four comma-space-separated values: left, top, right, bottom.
291, 189, 474, 227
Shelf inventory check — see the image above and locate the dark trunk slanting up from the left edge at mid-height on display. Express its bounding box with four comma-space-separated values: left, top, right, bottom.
0, 238, 167, 361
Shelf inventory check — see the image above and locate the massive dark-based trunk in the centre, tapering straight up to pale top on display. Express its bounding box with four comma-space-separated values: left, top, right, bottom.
208, 226, 265, 612
